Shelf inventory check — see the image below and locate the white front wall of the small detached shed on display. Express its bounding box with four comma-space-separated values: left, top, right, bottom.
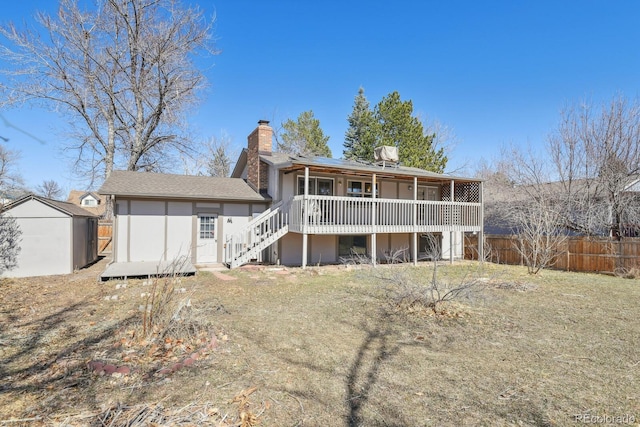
3, 217, 72, 277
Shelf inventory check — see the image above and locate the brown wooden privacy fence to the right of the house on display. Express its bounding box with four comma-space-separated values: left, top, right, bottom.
465, 234, 640, 273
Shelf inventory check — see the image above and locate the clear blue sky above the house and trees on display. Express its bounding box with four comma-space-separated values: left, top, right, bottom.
0, 0, 640, 194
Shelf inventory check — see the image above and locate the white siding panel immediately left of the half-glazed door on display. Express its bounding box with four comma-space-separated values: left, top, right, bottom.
165, 202, 193, 261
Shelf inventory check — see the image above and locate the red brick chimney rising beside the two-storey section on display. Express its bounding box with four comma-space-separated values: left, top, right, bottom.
247, 120, 273, 194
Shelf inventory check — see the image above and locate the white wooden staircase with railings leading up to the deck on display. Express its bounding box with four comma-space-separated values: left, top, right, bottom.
224, 201, 289, 268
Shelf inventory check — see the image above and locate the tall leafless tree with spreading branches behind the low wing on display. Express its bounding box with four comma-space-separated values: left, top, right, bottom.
0, 0, 215, 185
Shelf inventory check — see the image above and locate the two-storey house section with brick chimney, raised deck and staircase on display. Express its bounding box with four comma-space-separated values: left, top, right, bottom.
225, 121, 483, 267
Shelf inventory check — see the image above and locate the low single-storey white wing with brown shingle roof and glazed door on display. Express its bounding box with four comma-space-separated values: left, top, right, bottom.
98, 171, 271, 279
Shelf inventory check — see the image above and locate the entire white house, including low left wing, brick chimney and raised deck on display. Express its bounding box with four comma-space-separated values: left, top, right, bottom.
99, 121, 483, 271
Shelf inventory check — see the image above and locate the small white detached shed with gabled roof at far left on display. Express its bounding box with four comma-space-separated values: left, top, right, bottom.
2, 194, 98, 277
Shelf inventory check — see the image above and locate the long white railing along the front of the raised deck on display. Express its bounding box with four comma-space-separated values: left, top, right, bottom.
289, 196, 482, 234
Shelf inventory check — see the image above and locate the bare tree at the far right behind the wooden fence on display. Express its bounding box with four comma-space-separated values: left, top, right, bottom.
548, 96, 640, 237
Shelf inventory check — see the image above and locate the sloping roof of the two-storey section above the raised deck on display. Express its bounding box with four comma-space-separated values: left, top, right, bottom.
260, 153, 482, 181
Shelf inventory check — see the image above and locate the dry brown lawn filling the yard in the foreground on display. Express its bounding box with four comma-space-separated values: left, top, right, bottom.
0, 262, 640, 427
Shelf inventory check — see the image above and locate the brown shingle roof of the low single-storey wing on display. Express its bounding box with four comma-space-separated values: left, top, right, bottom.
98, 171, 269, 202
